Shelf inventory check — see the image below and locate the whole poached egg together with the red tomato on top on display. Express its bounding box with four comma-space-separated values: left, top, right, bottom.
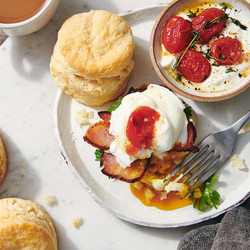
109, 84, 188, 168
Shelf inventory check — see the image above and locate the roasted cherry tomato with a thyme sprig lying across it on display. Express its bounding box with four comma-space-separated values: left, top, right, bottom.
192, 8, 227, 44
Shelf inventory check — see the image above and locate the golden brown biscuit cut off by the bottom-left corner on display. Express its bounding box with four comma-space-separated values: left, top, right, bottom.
0, 198, 57, 250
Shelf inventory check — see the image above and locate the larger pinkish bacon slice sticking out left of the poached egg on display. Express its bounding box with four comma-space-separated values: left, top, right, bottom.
83, 121, 114, 150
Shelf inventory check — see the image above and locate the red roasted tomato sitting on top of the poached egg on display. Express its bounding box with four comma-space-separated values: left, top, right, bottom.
126, 107, 160, 156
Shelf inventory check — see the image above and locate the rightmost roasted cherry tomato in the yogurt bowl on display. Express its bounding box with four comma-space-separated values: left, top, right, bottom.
211, 37, 242, 65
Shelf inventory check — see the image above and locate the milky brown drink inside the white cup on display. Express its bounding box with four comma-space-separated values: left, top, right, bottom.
0, 0, 46, 23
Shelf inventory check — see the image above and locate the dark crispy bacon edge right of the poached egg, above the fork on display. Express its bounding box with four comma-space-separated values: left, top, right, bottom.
171, 122, 199, 152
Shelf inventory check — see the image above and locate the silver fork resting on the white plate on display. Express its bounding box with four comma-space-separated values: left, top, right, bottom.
164, 110, 250, 195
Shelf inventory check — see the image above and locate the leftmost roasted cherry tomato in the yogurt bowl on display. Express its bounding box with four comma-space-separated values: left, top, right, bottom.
162, 16, 193, 53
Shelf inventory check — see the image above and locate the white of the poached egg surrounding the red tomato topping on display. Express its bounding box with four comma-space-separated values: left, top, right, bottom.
109, 84, 188, 168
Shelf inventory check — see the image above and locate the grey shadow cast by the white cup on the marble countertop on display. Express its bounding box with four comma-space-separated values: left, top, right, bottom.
8, 0, 117, 83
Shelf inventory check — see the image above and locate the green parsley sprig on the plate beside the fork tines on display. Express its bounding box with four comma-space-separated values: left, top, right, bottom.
189, 175, 220, 211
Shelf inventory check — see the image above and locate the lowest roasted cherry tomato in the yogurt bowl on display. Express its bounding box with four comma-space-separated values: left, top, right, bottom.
177, 50, 211, 83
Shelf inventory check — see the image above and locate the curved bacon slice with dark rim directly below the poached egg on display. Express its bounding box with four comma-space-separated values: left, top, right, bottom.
101, 152, 150, 183
